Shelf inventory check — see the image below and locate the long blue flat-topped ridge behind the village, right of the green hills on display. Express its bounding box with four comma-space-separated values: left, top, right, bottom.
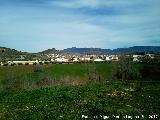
62, 46, 160, 54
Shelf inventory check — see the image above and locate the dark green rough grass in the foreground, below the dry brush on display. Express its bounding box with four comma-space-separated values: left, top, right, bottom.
0, 81, 160, 120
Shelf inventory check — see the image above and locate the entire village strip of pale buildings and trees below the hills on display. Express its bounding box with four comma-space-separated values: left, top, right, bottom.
0, 54, 155, 66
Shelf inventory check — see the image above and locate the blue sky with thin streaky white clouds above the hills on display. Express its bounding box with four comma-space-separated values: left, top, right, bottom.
0, 0, 160, 52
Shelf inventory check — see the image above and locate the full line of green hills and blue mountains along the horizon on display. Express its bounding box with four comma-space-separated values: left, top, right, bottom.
0, 46, 160, 56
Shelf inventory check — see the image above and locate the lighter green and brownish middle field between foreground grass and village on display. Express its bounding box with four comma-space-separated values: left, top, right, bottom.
0, 63, 112, 90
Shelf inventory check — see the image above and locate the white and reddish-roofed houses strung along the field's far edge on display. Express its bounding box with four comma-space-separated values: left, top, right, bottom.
0, 54, 154, 65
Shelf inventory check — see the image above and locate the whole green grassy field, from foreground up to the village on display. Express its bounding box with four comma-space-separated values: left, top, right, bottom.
0, 63, 160, 120
